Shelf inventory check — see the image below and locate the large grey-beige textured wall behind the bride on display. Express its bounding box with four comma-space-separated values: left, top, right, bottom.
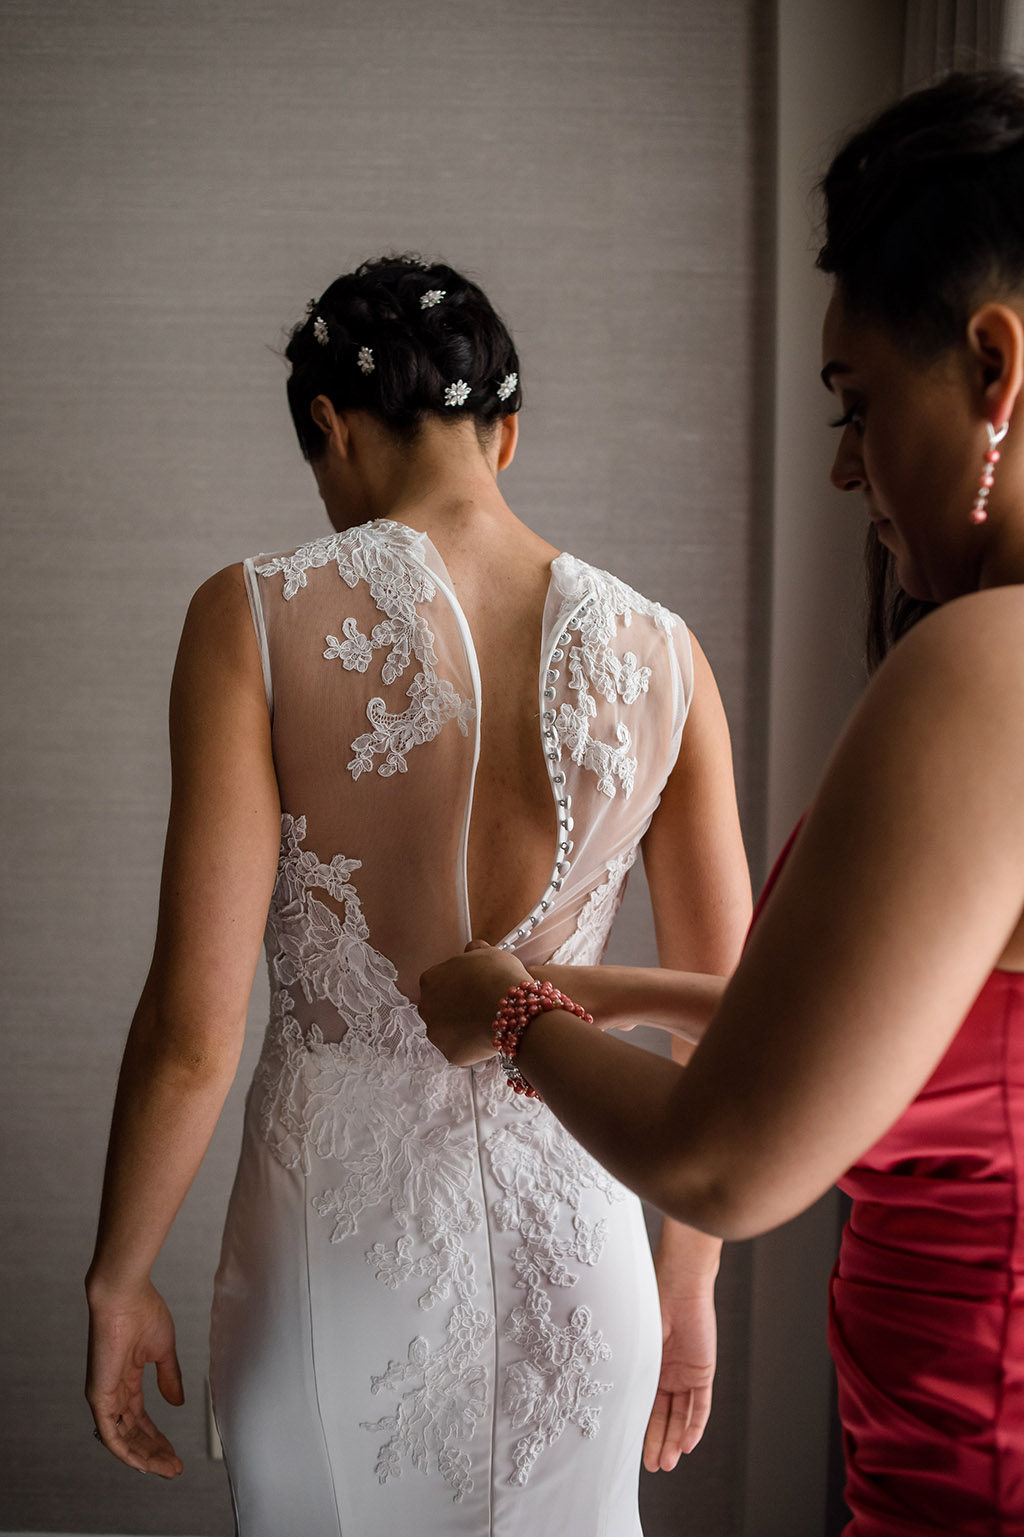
0, 0, 770, 1537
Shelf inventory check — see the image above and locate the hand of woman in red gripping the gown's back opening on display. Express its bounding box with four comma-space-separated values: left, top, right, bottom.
418, 939, 530, 1067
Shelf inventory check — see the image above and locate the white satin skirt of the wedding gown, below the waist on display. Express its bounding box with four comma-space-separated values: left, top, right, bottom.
211, 1069, 661, 1537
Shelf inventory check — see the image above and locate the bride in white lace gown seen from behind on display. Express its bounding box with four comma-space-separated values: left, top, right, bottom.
88, 257, 749, 1537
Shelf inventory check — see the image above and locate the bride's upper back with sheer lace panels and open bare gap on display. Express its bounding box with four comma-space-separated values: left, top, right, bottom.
248, 507, 692, 1028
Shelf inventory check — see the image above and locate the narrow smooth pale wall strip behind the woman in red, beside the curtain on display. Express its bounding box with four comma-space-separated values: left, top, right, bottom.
744, 0, 904, 1537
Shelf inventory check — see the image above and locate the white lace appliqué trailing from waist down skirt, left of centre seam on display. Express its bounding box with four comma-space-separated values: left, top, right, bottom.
254, 815, 482, 1500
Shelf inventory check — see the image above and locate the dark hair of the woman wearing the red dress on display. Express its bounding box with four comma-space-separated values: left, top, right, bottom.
818, 69, 1024, 667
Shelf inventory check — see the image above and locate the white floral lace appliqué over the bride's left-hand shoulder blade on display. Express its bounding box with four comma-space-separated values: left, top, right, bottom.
257, 520, 475, 779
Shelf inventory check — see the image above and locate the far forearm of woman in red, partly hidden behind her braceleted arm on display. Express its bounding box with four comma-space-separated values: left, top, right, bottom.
532, 965, 726, 1044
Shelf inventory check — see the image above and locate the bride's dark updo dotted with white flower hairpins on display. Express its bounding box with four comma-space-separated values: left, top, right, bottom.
284, 255, 523, 460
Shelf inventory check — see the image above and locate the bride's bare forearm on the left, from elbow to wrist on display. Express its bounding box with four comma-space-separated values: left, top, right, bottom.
86, 996, 244, 1300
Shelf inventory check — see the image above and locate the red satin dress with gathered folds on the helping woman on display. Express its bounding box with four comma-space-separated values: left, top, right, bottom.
766, 836, 1024, 1537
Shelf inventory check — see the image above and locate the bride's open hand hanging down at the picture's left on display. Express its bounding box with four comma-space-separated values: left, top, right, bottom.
86, 1282, 185, 1479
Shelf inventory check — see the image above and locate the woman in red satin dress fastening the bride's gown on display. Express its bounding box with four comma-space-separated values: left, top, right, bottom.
421, 72, 1024, 1537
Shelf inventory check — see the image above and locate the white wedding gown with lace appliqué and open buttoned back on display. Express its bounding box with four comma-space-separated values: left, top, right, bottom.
211, 521, 692, 1537
